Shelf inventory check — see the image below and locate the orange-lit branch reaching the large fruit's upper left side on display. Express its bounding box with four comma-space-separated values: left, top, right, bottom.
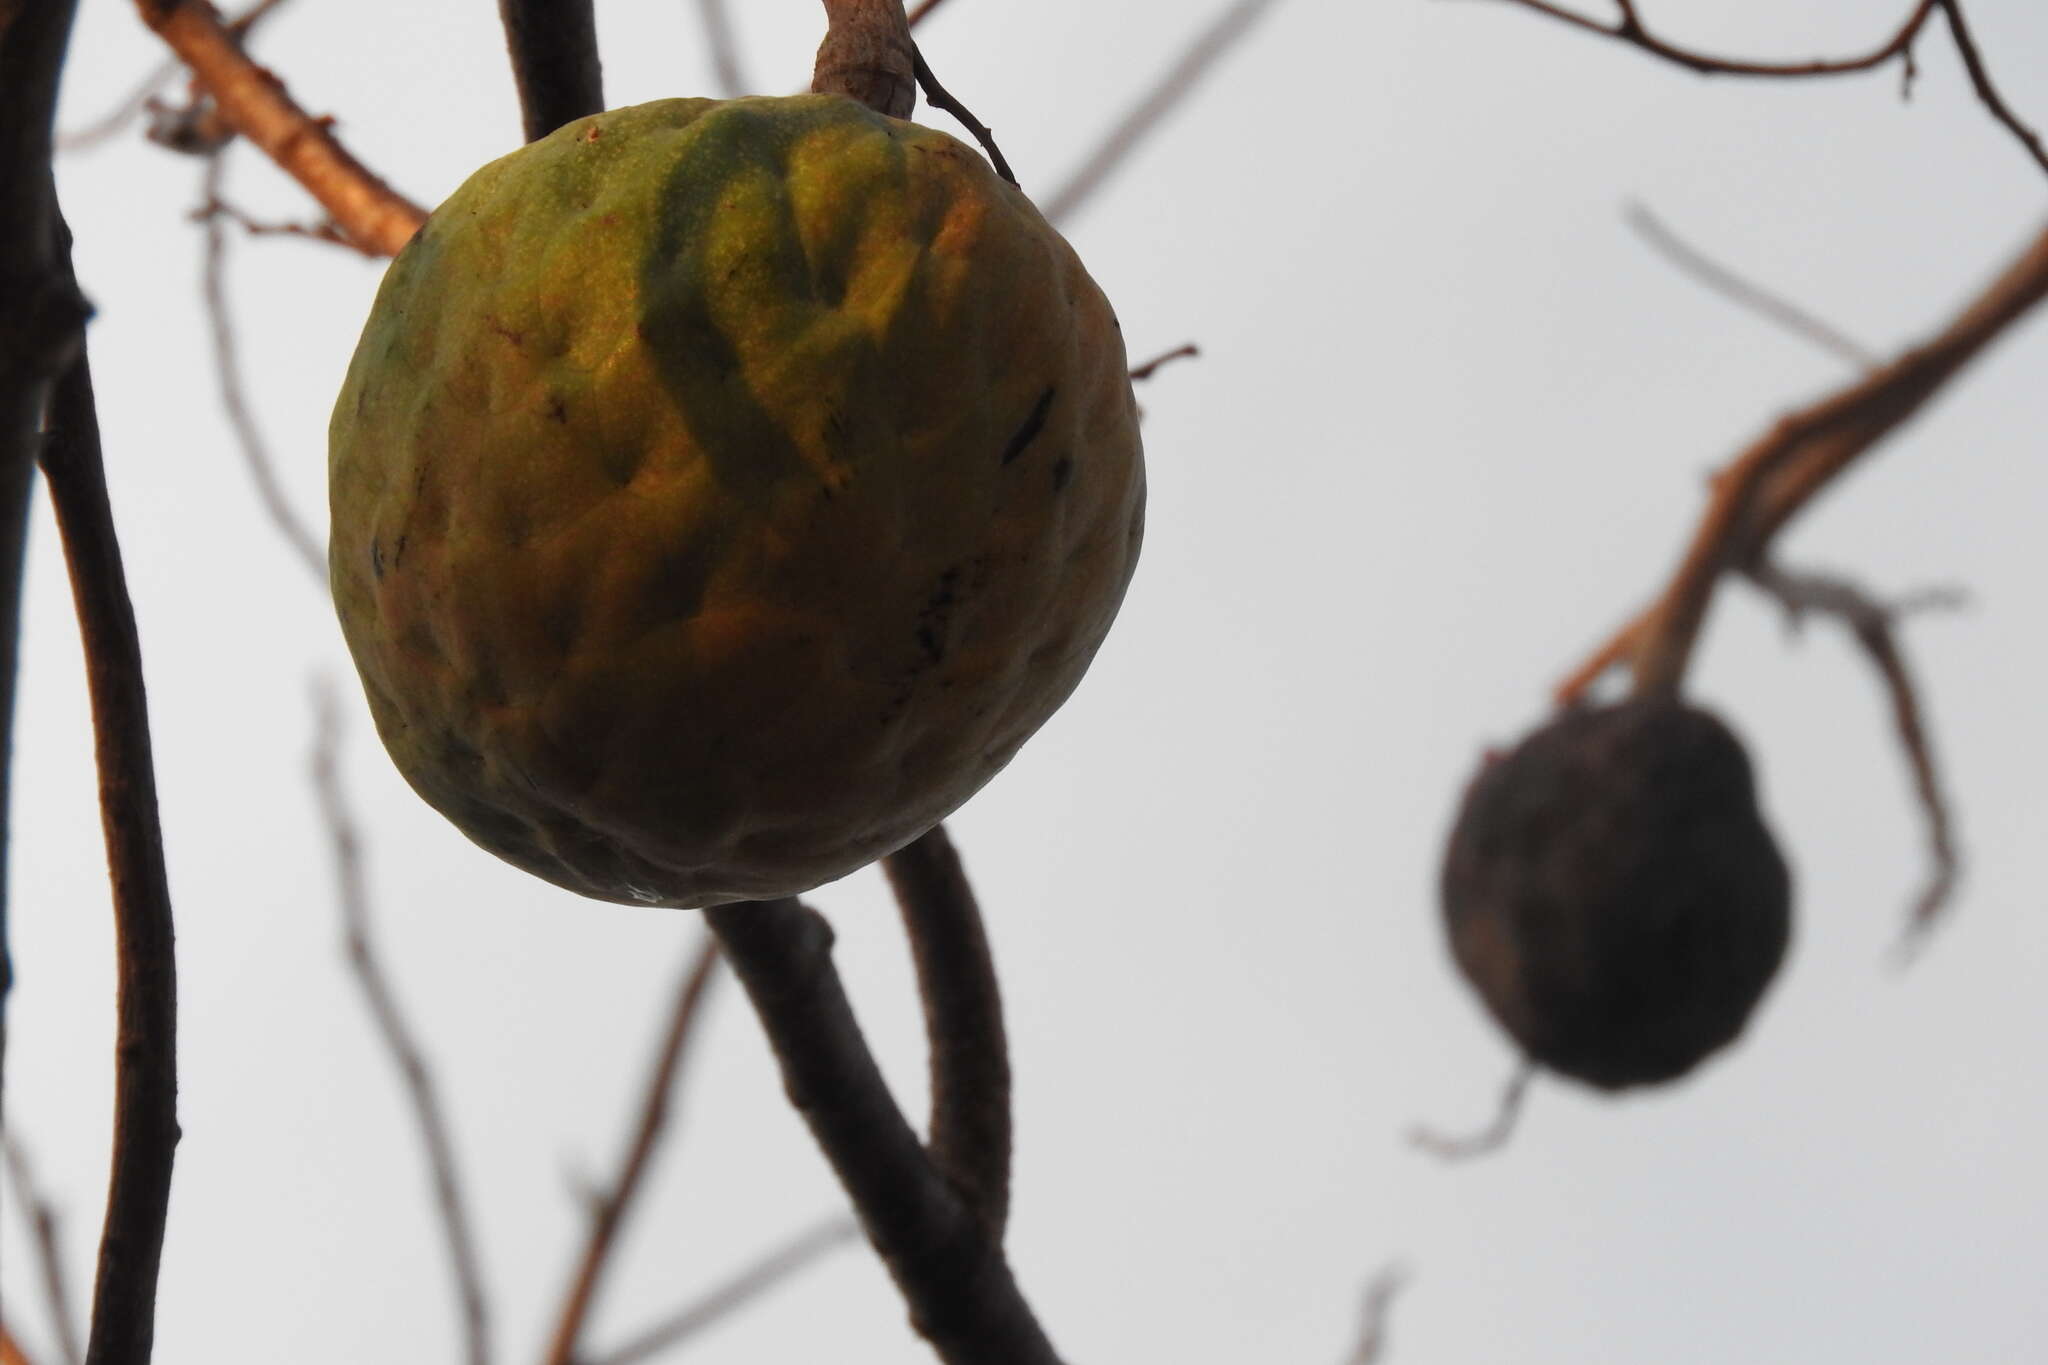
135, 0, 426, 256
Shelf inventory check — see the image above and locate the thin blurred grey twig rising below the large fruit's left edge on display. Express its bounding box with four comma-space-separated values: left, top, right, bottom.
311, 684, 492, 1365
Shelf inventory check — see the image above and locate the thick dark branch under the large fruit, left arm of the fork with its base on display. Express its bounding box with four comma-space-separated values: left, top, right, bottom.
705, 900, 1059, 1365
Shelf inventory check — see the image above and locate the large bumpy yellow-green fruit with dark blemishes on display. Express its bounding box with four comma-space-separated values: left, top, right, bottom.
330, 96, 1145, 907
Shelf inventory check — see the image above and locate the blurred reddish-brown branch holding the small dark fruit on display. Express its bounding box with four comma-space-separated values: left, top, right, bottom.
1556, 215, 2048, 704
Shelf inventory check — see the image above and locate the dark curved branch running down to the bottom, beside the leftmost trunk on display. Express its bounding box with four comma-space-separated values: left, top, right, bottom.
41, 339, 178, 1365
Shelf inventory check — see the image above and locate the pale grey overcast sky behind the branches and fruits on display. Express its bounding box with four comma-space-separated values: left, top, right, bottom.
0, 0, 2048, 1365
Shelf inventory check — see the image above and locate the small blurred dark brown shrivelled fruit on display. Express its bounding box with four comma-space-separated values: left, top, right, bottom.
1442, 698, 1792, 1091
